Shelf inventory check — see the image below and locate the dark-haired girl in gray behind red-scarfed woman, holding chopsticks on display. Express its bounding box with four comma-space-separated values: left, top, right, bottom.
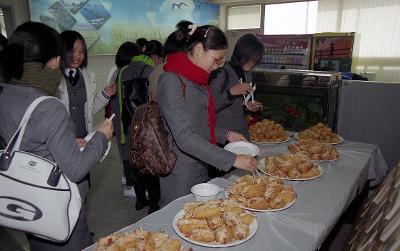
210, 34, 264, 140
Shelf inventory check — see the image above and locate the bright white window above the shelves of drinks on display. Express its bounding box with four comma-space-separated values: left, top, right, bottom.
264, 1, 318, 35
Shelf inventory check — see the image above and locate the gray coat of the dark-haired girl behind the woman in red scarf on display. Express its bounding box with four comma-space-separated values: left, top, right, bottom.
210, 63, 252, 139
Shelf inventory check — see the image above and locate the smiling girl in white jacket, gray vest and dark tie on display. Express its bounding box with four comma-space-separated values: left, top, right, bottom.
57, 30, 116, 147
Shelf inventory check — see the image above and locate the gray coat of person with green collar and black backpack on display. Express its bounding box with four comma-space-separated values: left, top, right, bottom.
111, 62, 153, 161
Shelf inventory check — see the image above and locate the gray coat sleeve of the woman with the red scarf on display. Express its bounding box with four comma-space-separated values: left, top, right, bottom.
157, 73, 236, 171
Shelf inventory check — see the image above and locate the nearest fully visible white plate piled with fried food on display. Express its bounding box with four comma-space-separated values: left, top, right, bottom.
173, 199, 258, 247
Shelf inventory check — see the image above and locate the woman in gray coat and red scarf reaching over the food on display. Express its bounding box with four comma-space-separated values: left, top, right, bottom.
157, 25, 257, 206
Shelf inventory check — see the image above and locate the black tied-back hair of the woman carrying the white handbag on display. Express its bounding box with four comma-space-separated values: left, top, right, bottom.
1, 22, 63, 82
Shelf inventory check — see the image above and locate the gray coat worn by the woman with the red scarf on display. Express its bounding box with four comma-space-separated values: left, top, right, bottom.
157, 72, 236, 206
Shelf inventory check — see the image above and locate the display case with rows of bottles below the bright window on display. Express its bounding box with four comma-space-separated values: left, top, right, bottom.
258, 35, 312, 70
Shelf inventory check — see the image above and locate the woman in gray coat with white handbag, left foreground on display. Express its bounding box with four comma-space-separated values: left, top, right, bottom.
0, 22, 113, 251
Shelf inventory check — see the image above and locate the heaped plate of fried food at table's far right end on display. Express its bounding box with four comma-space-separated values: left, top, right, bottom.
294, 123, 344, 145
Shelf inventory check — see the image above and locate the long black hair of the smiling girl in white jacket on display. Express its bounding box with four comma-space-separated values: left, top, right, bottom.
61, 30, 87, 72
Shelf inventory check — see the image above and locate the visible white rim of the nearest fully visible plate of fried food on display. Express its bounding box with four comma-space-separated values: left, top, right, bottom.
172, 209, 258, 248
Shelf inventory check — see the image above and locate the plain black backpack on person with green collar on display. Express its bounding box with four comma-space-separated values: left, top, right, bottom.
119, 65, 148, 134
